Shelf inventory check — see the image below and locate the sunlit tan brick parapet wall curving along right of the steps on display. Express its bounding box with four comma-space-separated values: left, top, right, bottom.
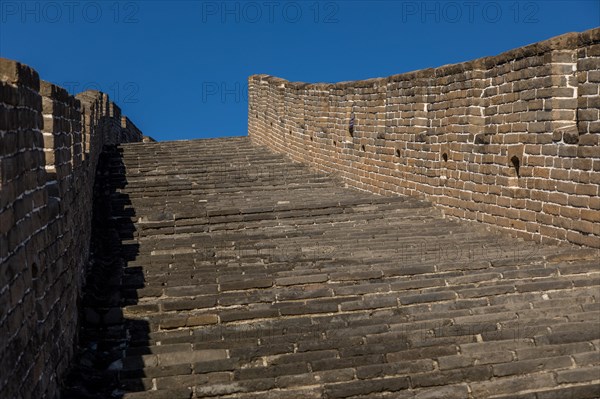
248, 28, 600, 248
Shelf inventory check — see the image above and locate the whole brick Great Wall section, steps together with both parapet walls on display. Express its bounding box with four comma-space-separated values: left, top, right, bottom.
0, 28, 600, 398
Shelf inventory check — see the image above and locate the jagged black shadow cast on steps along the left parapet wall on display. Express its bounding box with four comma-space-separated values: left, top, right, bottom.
62, 146, 149, 399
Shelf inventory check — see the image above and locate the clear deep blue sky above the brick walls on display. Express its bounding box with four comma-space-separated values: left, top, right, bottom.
0, 0, 600, 140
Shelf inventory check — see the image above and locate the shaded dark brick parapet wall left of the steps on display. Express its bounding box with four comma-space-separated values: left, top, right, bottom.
0, 58, 142, 398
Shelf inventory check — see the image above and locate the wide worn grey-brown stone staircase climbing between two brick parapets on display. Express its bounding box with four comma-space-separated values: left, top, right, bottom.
66, 137, 600, 399
